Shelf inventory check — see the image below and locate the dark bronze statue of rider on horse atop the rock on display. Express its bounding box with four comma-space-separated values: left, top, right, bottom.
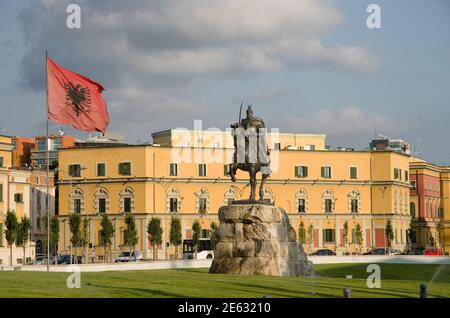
229, 104, 271, 201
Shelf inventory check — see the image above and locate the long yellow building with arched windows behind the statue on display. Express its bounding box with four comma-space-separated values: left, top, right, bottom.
59, 130, 410, 258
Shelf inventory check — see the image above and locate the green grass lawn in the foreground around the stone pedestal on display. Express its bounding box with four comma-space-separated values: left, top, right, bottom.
0, 264, 450, 298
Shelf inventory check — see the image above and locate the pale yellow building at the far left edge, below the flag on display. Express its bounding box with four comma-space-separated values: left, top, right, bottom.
0, 136, 55, 265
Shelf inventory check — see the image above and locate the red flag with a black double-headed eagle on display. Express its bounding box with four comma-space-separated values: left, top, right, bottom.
47, 58, 109, 133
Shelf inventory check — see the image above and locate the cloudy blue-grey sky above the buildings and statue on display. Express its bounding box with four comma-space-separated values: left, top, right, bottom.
0, 0, 450, 165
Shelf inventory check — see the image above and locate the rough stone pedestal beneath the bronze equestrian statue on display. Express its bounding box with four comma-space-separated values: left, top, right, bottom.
209, 203, 314, 276
